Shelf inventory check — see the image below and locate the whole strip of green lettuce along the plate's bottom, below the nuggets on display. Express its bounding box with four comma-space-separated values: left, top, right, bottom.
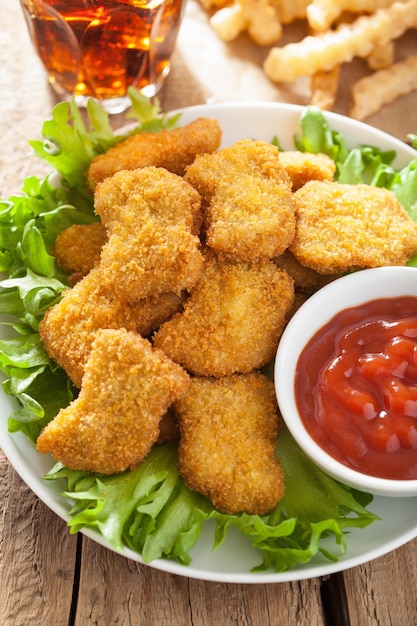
46, 429, 378, 572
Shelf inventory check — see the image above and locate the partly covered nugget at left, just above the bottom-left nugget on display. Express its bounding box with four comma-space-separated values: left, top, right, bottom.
39, 266, 181, 387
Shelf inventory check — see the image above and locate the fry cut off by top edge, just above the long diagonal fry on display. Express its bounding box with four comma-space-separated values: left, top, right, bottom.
306, 0, 405, 32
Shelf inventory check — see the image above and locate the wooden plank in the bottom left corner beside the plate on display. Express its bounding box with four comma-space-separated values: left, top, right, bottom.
0, 456, 77, 626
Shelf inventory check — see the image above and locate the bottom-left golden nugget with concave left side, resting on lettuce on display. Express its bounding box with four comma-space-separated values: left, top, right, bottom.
36, 329, 189, 474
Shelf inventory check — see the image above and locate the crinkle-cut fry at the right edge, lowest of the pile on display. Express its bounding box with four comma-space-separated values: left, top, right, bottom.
350, 54, 417, 120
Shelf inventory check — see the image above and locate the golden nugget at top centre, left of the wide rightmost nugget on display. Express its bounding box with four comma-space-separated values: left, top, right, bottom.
185, 139, 295, 261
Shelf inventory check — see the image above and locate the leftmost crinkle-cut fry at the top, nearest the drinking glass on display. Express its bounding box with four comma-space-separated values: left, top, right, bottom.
210, 0, 282, 46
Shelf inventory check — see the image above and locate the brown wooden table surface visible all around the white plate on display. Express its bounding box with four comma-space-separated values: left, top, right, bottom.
0, 0, 417, 626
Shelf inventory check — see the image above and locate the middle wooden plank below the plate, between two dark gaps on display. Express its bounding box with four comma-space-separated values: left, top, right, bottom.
74, 538, 325, 626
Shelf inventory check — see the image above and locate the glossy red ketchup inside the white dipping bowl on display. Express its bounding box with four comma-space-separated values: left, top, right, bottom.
295, 296, 417, 480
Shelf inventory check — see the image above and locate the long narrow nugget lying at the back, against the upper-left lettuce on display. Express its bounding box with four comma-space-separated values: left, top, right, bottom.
87, 117, 222, 191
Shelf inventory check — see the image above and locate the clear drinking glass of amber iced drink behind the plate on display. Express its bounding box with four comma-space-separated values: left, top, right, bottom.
20, 0, 185, 113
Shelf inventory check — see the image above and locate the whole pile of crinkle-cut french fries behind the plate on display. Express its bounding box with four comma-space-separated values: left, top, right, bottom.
200, 0, 417, 120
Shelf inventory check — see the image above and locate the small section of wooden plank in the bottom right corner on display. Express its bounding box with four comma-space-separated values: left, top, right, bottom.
344, 540, 417, 626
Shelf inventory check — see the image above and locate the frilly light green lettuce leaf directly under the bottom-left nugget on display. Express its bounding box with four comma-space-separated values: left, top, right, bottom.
45, 444, 213, 564
